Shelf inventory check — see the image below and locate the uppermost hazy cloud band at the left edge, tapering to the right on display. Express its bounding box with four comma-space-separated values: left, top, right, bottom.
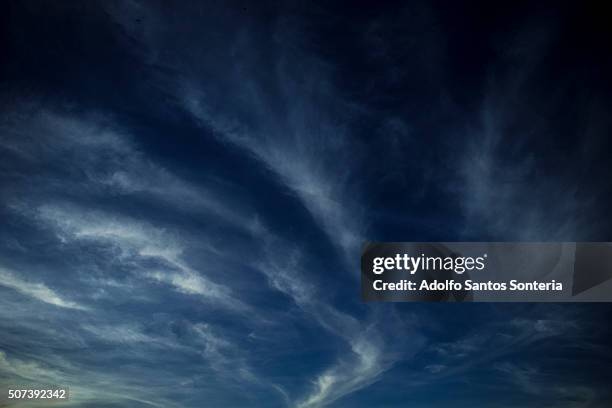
0, 108, 266, 233
